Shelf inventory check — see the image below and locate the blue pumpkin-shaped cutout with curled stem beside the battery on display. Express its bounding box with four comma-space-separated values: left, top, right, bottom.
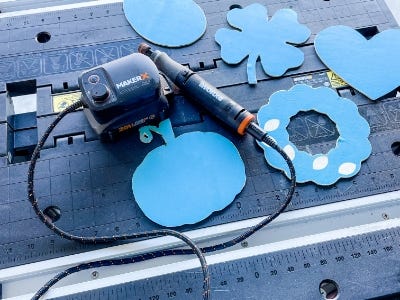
132, 119, 246, 227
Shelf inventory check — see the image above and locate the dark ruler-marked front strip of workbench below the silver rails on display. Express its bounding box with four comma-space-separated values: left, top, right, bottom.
49, 224, 400, 300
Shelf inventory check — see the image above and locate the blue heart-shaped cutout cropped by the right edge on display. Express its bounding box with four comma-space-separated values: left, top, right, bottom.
314, 25, 400, 100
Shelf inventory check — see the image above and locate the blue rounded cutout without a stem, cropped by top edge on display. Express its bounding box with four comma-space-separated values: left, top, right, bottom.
123, 0, 207, 47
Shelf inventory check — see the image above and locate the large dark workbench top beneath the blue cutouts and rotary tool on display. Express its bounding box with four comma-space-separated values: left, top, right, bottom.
0, 0, 400, 268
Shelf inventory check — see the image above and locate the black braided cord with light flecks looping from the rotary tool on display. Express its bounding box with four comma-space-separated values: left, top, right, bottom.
28, 101, 296, 300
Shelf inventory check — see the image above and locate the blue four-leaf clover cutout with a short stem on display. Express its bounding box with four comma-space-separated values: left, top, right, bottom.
215, 3, 311, 84
